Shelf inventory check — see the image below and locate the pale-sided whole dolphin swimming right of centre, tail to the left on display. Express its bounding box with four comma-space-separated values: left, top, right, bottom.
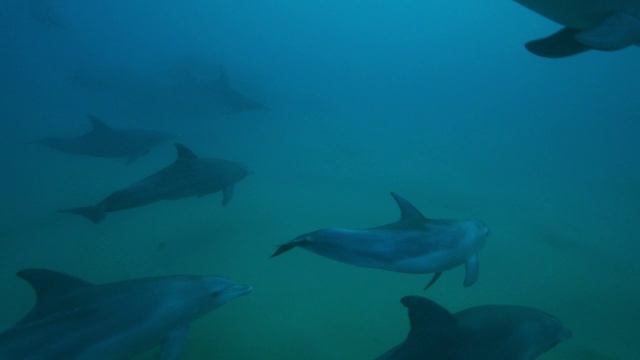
271, 192, 489, 289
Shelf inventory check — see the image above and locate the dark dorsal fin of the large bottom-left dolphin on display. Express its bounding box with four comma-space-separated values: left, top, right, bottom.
17, 269, 93, 303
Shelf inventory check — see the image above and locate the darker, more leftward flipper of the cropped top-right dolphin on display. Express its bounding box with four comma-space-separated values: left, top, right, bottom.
524, 28, 591, 58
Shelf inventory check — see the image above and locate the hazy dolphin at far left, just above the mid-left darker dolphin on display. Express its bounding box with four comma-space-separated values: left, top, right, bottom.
36, 116, 175, 164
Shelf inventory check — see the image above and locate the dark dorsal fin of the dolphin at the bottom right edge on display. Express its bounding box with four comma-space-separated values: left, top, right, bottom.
400, 296, 458, 336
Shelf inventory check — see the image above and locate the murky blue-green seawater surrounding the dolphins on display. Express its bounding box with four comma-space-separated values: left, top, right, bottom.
0, 0, 640, 360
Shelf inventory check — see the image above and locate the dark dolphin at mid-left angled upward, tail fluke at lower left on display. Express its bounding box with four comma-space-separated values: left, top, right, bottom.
59, 143, 249, 223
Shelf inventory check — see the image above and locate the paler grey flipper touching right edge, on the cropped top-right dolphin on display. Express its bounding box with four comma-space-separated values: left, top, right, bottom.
575, 13, 640, 51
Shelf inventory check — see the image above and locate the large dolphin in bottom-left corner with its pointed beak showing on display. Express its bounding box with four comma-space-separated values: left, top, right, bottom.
0, 269, 251, 360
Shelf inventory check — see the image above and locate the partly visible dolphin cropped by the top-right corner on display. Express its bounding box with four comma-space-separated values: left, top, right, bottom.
515, 0, 640, 58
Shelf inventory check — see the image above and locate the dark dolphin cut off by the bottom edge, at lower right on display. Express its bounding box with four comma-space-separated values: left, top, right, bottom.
377, 296, 572, 360
